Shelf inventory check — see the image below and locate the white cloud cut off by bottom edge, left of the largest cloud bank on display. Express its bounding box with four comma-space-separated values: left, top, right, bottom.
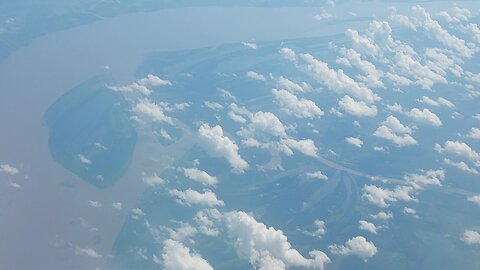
162, 239, 213, 270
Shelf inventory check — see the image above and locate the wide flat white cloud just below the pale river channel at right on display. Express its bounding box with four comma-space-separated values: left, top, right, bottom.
362, 185, 417, 208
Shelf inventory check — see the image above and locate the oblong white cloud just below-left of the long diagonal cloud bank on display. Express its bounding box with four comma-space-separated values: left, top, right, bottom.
272, 89, 324, 118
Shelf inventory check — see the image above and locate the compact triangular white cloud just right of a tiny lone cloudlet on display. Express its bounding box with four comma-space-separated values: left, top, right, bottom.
373, 115, 417, 147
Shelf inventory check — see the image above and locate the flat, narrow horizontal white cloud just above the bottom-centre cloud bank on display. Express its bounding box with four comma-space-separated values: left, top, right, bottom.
169, 188, 225, 207
